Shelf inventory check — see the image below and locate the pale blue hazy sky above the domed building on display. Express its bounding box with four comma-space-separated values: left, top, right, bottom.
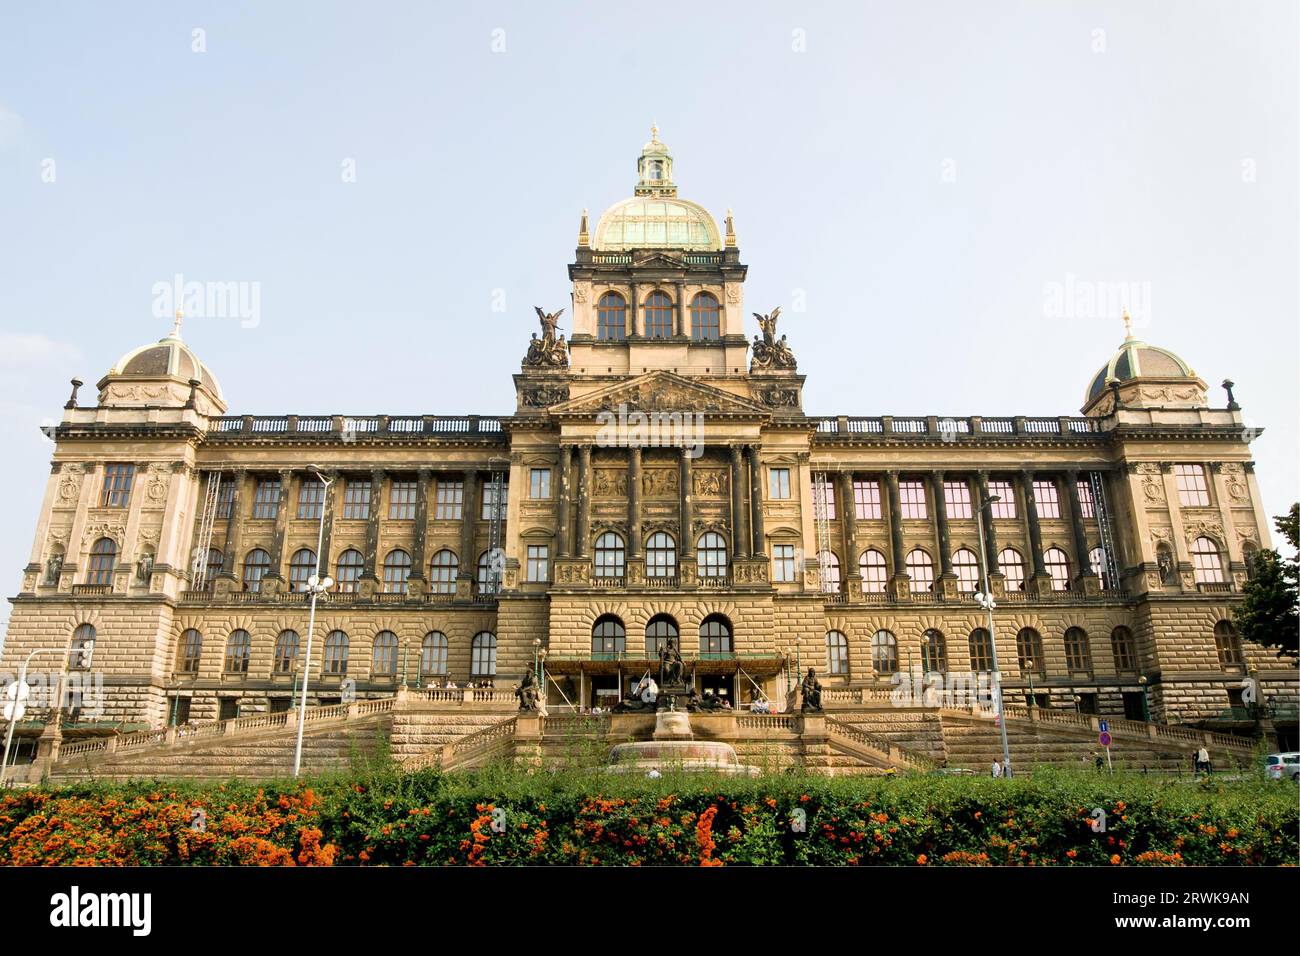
0, 0, 1300, 634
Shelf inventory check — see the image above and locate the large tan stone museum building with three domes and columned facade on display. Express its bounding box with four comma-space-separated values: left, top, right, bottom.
0, 133, 1296, 728
